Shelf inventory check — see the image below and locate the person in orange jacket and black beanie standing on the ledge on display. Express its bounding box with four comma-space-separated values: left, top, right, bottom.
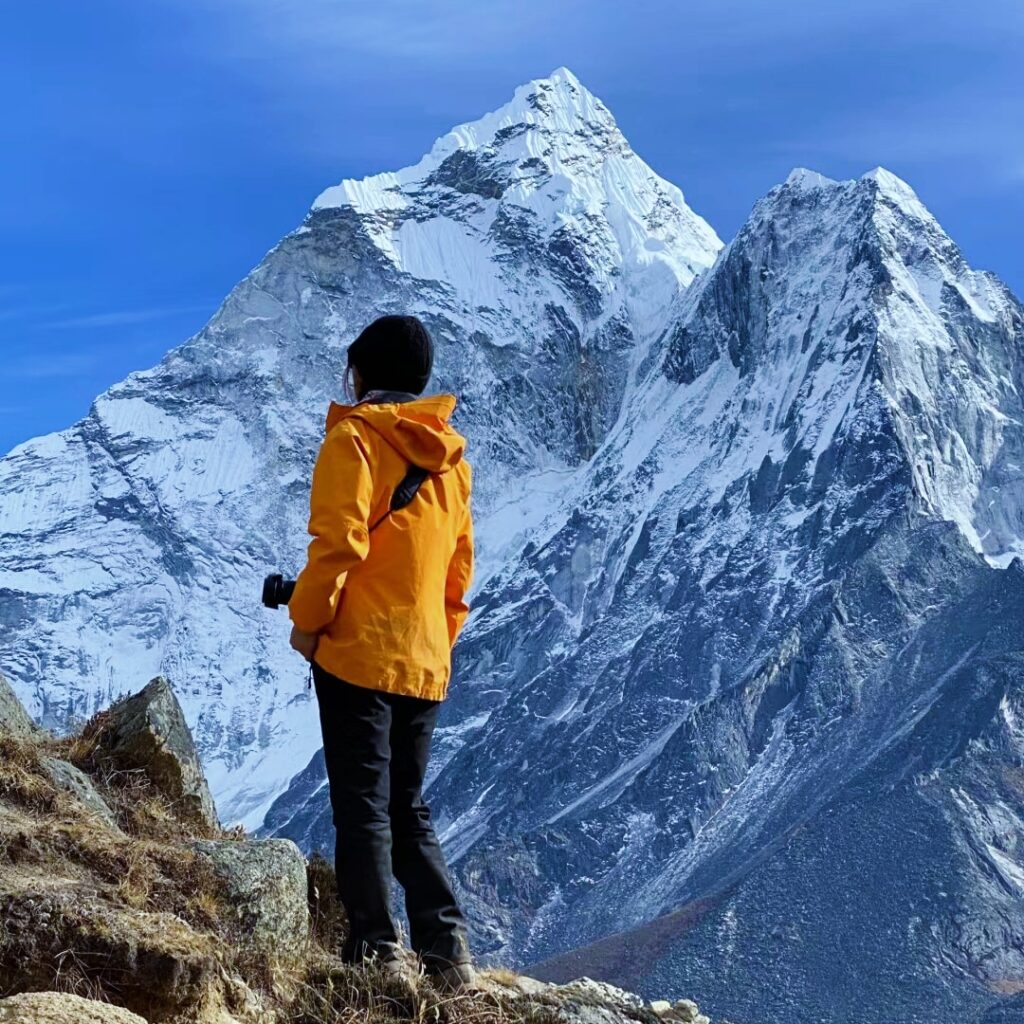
289, 316, 475, 990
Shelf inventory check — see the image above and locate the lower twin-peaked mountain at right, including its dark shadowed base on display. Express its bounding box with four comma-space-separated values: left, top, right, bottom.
268, 170, 1024, 1024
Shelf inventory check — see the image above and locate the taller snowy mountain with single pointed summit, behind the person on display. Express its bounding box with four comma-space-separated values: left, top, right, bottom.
0, 70, 721, 825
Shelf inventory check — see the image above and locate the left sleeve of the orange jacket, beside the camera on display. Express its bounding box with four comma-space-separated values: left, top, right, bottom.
288, 427, 373, 633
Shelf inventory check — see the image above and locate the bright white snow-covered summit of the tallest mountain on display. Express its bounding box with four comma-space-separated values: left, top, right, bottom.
312, 68, 722, 303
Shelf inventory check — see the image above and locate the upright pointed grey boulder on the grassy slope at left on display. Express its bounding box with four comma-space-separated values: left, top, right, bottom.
97, 676, 220, 830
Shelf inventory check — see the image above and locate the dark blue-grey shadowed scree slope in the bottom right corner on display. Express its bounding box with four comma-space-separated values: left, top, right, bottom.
532, 529, 1024, 1024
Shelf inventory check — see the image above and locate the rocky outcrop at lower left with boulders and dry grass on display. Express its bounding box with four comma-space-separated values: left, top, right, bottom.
0, 679, 299, 1024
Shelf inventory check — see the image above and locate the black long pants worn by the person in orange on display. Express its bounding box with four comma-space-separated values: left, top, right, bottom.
313, 664, 470, 968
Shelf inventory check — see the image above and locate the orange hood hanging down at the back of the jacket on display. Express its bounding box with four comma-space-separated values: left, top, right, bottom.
327, 394, 466, 473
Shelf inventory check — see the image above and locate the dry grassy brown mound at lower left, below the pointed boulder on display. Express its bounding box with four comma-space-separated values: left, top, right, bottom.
0, 723, 247, 1022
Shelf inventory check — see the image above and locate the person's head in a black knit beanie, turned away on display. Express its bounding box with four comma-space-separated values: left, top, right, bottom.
346, 316, 434, 399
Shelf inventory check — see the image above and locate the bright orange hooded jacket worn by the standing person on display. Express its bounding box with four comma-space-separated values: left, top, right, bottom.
288, 394, 473, 700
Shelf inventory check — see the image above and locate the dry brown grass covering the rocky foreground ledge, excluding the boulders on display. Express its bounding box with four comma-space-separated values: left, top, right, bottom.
0, 713, 569, 1024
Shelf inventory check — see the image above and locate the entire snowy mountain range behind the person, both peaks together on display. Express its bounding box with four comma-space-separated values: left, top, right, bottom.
0, 71, 1024, 1024
